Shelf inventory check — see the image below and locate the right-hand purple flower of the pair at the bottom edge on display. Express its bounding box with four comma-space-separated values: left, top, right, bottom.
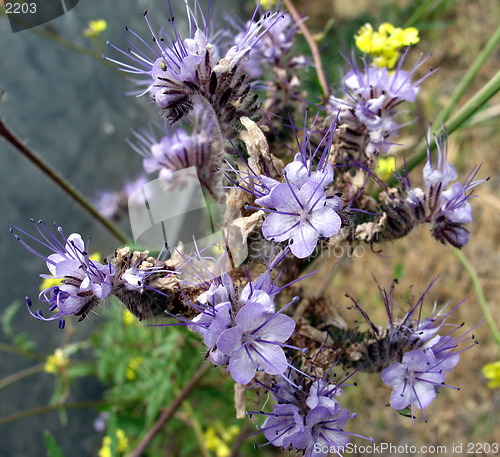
291, 404, 351, 457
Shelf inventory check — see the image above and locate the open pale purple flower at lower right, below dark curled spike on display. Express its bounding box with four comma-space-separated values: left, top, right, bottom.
382, 349, 446, 416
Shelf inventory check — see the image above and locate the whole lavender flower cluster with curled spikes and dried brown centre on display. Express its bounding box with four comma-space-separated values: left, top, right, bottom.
11, 0, 484, 456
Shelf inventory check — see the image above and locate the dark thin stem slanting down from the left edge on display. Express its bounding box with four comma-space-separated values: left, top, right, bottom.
0, 119, 128, 243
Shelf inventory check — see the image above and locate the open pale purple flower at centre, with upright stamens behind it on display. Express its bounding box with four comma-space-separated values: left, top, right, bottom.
233, 120, 343, 258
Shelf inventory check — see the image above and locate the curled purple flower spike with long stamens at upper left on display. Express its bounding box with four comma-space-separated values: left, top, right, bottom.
106, 0, 281, 136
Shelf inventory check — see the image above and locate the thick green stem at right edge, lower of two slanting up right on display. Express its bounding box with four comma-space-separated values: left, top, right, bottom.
387, 71, 500, 187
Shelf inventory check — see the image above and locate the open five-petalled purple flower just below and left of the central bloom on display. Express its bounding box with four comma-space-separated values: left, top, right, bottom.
217, 302, 295, 384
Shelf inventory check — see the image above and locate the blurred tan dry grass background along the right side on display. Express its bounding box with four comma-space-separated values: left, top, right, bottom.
294, 0, 500, 456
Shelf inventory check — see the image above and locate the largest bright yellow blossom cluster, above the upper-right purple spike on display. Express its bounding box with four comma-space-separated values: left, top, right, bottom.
354, 22, 420, 69
